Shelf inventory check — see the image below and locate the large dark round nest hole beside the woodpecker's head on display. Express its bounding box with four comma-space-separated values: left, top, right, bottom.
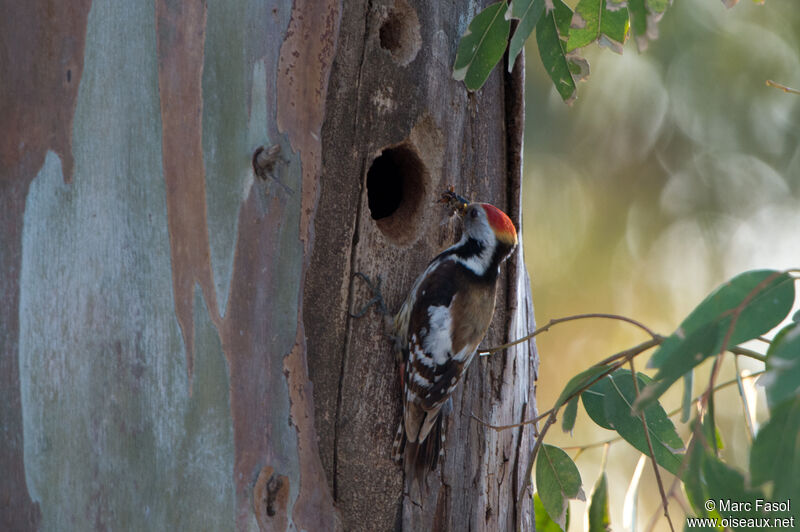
367, 144, 428, 244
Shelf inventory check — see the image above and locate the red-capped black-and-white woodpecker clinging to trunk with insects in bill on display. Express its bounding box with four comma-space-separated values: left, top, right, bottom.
393, 189, 517, 471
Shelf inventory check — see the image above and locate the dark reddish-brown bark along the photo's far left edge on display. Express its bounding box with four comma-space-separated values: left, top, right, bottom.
0, 0, 90, 530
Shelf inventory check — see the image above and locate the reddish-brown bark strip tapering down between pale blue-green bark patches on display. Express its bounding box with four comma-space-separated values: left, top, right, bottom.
156, 0, 220, 381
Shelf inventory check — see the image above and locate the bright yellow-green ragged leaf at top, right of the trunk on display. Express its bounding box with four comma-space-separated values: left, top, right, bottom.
567, 0, 629, 54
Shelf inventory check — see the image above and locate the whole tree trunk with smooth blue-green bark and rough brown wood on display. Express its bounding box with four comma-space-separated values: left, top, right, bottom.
0, 0, 536, 530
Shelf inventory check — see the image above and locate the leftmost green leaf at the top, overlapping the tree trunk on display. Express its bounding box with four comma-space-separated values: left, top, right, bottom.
453, 1, 511, 91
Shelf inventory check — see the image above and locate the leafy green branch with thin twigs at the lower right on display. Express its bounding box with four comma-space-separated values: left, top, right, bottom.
488, 270, 800, 530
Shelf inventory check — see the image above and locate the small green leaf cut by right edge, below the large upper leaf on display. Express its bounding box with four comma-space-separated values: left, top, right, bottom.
759, 323, 800, 410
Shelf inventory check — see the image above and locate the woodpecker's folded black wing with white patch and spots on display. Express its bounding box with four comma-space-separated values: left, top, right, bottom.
404, 256, 496, 442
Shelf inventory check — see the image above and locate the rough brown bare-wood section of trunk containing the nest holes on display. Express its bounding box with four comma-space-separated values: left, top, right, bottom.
304, 0, 536, 530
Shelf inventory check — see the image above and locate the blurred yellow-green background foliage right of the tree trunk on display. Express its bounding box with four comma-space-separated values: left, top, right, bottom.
523, 0, 800, 531
